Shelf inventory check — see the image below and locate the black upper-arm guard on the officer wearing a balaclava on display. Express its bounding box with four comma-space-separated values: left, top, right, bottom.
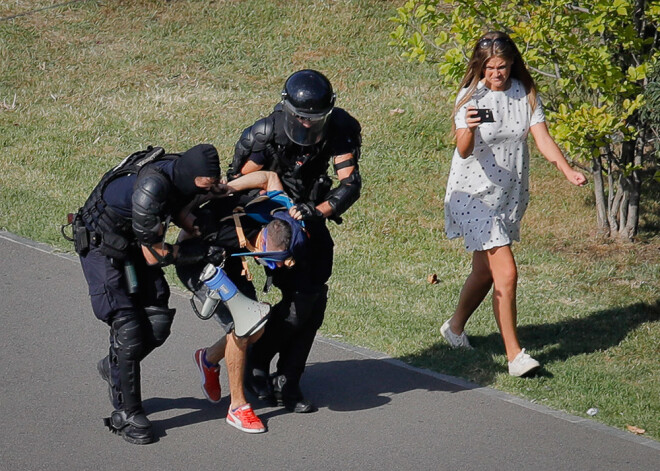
133, 173, 169, 245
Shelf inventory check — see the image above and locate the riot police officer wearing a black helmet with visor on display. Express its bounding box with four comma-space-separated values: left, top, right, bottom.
228, 69, 362, 412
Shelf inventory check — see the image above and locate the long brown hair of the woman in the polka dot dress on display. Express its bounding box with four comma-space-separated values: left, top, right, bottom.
451, 31, 536, 134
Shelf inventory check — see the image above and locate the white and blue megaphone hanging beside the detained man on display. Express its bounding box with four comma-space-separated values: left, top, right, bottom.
199, 263, 270, 337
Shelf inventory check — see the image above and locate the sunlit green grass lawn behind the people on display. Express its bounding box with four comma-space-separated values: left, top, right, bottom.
0, 0, 660, 439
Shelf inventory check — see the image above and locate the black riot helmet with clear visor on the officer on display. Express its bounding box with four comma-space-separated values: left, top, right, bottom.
282, 69, 335, 146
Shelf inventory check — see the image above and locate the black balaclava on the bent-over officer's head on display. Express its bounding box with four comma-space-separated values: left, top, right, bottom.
172, 144, 220, 195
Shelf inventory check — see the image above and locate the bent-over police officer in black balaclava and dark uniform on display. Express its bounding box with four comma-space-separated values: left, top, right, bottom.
73, 144, 222, 444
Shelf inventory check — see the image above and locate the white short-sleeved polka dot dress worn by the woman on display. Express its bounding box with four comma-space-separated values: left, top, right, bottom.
445, 79, 545, 252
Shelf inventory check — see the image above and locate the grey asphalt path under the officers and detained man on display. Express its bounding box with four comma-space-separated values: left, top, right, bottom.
0, 231, 660, 471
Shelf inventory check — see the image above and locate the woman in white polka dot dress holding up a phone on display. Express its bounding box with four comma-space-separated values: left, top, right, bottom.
440, 32, 586, 376
